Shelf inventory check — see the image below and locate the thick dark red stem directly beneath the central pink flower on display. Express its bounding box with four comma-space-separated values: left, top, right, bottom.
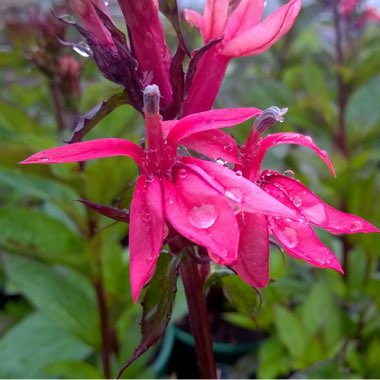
180, 251, 216, 379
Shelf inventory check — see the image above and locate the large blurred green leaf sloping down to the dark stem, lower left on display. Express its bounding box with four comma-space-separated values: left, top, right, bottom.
4, 255, 100, 347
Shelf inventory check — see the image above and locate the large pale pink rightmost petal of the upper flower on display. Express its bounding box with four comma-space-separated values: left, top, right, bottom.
222, 0, 301, 57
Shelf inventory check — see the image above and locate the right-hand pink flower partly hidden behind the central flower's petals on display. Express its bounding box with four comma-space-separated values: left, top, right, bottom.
232, 107, 379, 287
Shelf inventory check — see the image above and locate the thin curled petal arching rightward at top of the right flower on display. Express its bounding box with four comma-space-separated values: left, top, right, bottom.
246, 132, 335, 178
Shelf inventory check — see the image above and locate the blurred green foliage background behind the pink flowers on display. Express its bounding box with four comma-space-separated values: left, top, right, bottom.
0, 1, 380, 378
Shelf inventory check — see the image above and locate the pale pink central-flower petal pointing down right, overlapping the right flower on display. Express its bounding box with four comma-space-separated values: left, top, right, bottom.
183, 157, 299, 219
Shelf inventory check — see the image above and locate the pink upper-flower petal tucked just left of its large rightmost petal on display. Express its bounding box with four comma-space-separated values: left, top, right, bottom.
224, 0, 264, 41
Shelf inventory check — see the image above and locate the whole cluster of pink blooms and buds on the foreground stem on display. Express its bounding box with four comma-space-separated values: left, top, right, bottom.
22, 0, 378, 301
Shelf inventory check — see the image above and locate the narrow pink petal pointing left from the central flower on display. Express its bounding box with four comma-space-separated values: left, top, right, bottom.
20, 138, 143, 165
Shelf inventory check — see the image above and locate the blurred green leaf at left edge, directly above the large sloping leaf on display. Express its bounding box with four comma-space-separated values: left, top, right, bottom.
0, 207, 85, 266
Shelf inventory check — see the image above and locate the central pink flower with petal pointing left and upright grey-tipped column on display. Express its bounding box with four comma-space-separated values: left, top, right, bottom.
22, 85, 297, 302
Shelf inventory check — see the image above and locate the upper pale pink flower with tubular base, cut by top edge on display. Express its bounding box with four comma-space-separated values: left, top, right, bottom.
184, 0, 301, 115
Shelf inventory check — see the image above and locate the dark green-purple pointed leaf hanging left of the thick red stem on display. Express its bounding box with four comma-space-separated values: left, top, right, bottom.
119, 254, 180, 374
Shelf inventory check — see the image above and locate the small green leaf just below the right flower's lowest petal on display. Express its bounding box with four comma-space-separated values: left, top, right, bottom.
222, 275, 259, 317
